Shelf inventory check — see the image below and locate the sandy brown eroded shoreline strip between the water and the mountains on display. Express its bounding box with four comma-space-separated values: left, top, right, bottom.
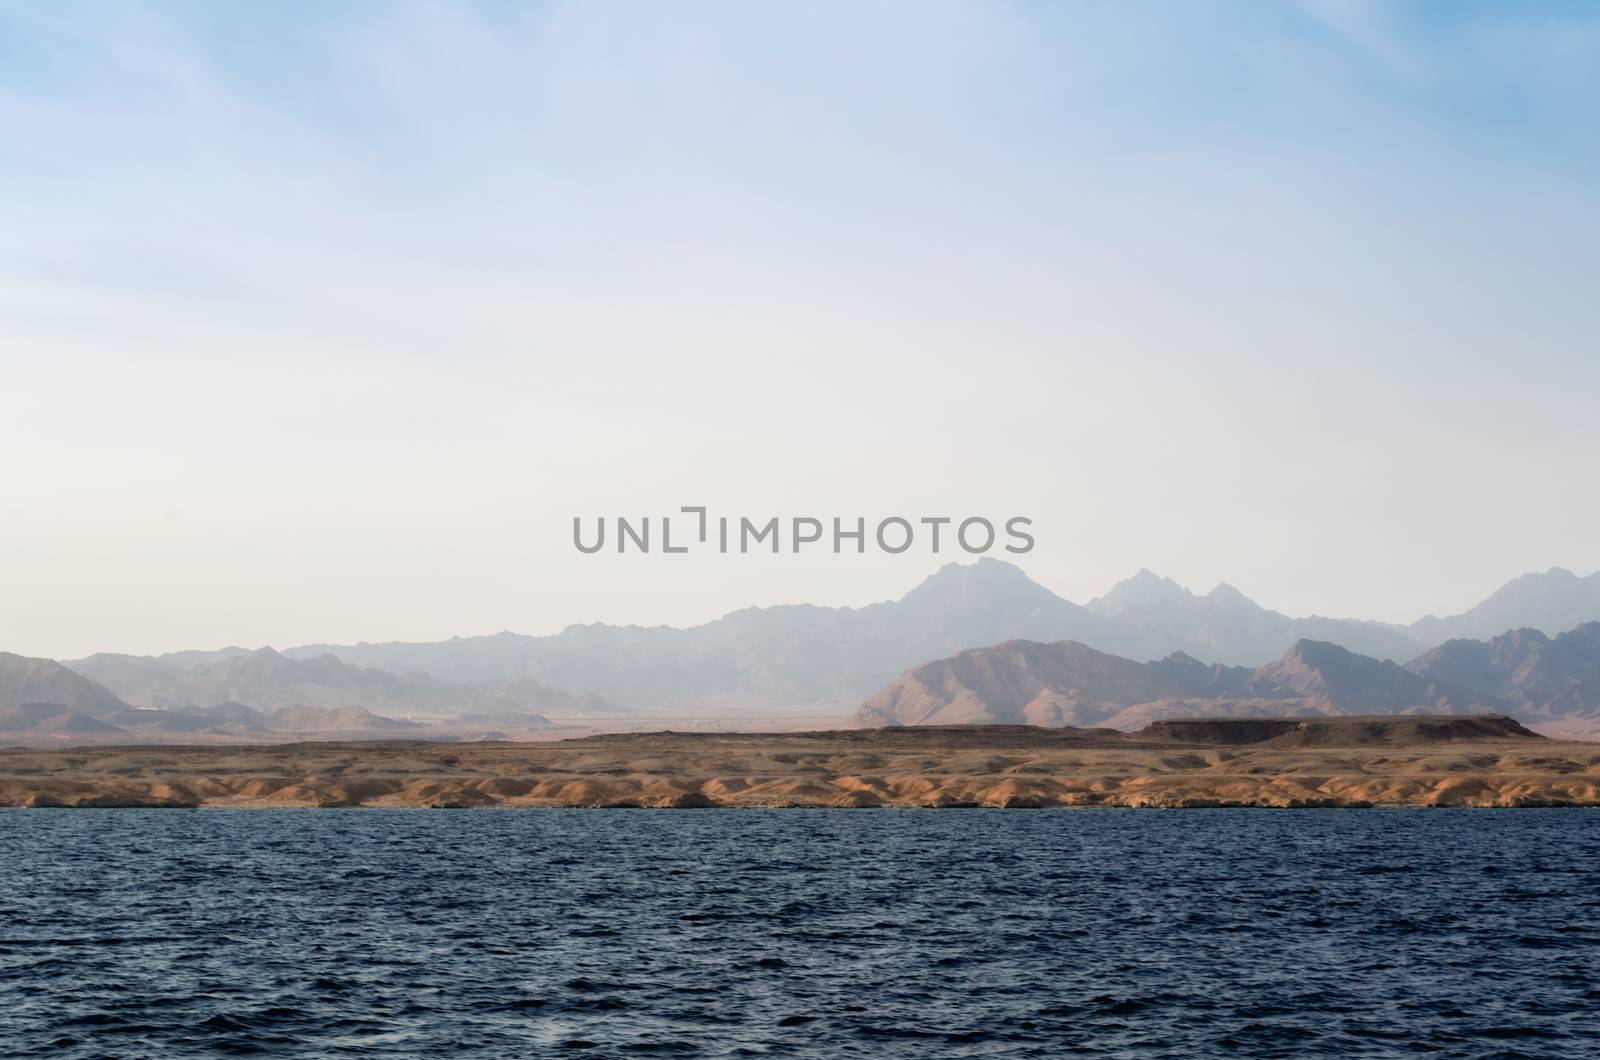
0, 716, 1600, 807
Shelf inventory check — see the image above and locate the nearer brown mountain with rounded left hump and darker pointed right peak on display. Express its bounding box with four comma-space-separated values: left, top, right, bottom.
854, 640, 1507, 729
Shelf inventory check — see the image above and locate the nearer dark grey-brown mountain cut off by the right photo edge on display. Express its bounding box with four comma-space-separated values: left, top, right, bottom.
1406, 621, 1600, 733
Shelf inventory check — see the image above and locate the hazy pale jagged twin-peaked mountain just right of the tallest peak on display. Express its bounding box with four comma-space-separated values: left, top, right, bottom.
1086, 570, 1426, 666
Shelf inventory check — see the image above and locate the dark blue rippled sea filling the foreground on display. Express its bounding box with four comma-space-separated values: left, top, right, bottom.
0, 810, 1600, 1060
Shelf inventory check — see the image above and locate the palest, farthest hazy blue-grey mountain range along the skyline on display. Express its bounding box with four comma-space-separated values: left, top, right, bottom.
268, 559, 1600, 709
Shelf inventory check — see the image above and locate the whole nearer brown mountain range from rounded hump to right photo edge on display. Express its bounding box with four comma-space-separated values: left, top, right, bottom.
853, 621, 1600, 735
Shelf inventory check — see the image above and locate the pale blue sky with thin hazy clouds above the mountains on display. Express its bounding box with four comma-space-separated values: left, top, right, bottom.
0, 0, 1600, 658
